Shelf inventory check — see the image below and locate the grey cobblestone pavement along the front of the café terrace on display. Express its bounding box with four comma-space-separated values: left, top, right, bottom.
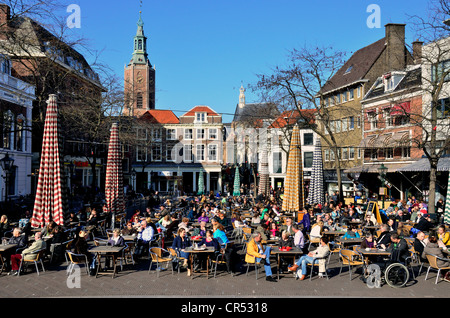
0, 250, 450, 299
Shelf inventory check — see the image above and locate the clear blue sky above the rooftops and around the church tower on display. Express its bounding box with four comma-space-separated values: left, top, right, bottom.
58, 0, 427, 122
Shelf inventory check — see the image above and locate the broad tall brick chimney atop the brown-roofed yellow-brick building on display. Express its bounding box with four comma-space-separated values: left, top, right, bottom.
385, 23, 407, 71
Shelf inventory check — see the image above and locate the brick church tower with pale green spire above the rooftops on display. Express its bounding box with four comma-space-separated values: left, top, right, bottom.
123, 12, 155, 117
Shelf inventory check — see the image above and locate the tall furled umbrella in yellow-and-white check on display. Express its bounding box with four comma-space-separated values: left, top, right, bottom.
282, 125, 304, 213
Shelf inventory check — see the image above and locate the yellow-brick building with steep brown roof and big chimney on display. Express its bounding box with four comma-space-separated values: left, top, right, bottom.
320, 23, 413, 195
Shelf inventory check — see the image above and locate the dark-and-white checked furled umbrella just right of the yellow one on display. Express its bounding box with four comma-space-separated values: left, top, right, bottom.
308, 138, 325, 205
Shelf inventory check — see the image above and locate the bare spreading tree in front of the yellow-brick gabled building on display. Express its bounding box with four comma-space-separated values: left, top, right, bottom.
254, 47, 348, 202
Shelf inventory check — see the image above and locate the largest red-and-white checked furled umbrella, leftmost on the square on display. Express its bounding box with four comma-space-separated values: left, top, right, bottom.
31, 94, 68, 228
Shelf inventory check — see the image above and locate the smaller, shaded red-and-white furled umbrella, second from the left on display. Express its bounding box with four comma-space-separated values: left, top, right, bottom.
103, 123, 125, 228
